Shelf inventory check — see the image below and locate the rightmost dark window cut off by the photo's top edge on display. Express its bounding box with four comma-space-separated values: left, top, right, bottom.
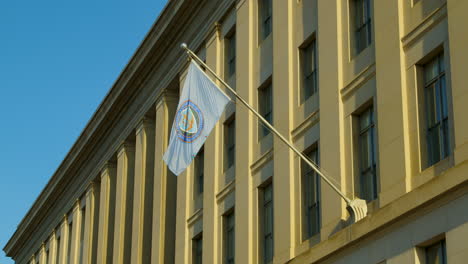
351, 0, 372, 54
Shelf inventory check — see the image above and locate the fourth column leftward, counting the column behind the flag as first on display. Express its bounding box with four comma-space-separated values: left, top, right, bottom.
97, 162, 116, 264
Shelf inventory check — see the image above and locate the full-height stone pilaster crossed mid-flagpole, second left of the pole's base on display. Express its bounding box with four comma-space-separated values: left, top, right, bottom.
273, 1, 297, 263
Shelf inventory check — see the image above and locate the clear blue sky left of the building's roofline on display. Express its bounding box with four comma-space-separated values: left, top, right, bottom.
0, 0, 167, 264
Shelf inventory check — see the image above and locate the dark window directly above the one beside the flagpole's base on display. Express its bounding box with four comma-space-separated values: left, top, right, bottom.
301, 40, 317, 102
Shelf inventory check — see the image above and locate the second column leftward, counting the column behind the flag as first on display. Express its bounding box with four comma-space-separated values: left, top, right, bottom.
131, 117, 154, 264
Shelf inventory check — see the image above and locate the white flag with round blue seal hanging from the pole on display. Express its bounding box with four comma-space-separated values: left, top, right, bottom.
163, 61, 230, 175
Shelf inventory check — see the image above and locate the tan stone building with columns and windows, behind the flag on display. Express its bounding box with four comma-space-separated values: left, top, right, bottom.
4, 0, 468, 264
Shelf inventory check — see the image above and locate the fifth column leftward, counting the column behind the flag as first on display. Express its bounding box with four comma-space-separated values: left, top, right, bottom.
83, 181, 99, 264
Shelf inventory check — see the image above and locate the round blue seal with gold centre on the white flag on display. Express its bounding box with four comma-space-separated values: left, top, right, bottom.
175, 100, 204, 143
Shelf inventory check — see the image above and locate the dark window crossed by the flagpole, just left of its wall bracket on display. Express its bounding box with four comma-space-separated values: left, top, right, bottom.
301, 148, 320, 239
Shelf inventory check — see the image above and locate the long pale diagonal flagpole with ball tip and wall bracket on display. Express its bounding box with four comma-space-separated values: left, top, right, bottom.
180, 43, 367, 221
